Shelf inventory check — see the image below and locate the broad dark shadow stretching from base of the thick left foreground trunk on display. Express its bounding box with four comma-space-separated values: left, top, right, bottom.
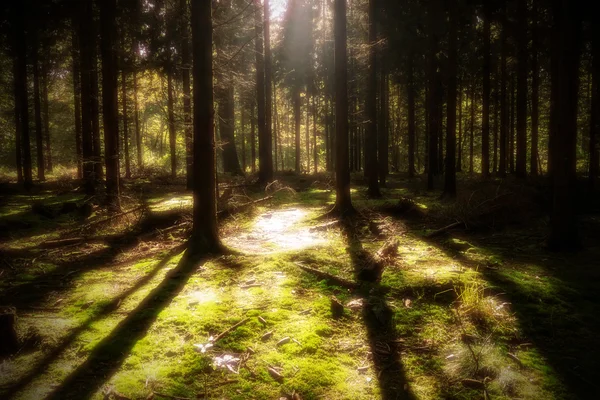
48, 247, 218, 400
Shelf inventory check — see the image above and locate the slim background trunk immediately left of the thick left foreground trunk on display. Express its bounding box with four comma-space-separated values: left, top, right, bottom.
179, 0, 194, 190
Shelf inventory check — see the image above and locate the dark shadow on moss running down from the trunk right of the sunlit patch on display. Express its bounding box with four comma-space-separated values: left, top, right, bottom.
342, 219, 414, 400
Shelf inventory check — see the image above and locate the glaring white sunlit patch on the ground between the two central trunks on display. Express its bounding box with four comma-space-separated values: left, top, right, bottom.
225, 208, 326, 254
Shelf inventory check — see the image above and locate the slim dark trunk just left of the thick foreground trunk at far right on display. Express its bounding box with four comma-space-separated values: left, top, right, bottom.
529, 1, 540, 176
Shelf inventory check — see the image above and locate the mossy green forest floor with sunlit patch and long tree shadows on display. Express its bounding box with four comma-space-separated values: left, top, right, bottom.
0, 175, 600, 400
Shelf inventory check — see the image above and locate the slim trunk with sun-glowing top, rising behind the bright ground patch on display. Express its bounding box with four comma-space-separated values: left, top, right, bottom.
259, 0, 273, 183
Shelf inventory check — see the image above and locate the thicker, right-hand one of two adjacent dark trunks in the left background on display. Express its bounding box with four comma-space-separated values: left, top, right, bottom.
99, 0, 121, 212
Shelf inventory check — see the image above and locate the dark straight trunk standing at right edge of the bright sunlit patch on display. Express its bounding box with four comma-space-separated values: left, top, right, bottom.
333, 0, 354, 215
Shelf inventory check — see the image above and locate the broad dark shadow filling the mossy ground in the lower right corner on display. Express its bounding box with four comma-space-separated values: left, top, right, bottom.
408, 223, 600, 399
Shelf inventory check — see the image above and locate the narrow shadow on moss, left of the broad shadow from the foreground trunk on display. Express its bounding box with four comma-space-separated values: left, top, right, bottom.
1, 245, 184, 398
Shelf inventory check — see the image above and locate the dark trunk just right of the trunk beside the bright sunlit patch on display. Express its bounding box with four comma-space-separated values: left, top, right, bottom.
366, 0, 381, 198
